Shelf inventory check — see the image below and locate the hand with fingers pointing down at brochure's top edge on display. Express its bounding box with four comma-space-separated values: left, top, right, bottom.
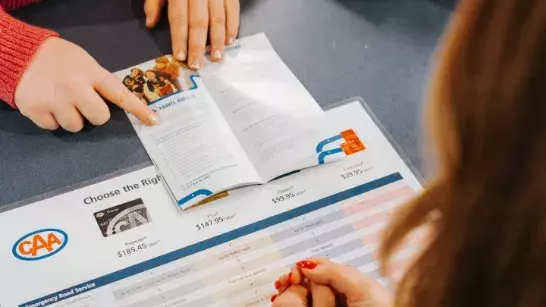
144, 0, 240, 70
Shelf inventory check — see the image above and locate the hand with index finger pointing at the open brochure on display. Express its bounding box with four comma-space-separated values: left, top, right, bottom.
15, 38, 156, 132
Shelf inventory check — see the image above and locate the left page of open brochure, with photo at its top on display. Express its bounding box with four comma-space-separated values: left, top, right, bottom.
117, 64, 261, 209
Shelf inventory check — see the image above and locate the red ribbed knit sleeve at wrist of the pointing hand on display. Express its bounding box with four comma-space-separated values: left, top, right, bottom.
0, 0, 58, 108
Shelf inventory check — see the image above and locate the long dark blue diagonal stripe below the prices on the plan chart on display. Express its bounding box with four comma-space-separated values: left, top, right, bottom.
19, 173, 403, 307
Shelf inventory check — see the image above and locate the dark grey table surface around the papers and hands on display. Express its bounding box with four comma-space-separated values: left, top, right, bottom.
0, 0, 453, 206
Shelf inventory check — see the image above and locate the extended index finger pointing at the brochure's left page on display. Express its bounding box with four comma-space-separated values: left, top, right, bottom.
95, 68, 158, 126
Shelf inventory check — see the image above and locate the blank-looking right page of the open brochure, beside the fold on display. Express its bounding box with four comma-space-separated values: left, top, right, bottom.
200, 33, 331, 181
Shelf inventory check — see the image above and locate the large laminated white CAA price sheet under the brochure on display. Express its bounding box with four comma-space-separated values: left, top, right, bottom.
0, 102, 421, 307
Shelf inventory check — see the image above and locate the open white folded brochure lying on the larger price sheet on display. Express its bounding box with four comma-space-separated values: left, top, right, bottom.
116, 34, 364, 209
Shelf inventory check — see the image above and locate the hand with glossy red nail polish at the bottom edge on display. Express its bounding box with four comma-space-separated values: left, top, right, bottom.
272, 258, 392, 307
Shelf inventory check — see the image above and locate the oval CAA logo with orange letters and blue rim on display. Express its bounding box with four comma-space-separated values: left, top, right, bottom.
12, 228, 68, 261
